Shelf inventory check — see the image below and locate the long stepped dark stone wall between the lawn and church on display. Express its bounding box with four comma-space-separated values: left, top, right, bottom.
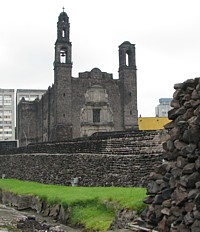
0, 132, 162, 186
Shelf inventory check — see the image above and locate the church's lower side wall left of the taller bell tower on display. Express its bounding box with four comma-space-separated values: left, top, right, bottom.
17, 86, 54, 146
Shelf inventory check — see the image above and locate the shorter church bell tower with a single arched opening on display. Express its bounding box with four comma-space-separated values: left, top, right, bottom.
119, 41, 138, 130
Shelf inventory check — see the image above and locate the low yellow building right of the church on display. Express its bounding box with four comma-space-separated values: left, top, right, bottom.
138, 117, 171, 130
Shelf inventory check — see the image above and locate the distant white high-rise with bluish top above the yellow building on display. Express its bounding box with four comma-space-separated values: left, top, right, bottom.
155, 98, 172, 117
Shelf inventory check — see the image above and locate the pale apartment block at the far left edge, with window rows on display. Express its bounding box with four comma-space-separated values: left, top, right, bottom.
0, 89, 15, 140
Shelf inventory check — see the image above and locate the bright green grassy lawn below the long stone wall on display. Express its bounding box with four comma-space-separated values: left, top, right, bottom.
0, 179, 146, 231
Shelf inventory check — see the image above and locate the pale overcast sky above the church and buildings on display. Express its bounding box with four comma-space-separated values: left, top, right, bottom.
0, 0, 200, 116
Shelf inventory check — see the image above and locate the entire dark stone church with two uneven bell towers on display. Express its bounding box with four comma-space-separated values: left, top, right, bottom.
17, 11, 138, 146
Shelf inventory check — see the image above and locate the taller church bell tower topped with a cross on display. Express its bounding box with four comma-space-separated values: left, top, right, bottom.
51, 8, 72, 141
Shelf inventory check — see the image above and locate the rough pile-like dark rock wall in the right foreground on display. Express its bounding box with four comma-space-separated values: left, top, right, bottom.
145, 78, 200, 232
